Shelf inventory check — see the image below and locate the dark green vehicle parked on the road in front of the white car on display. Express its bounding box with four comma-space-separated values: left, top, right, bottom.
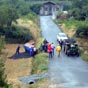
63, 39, 79, 56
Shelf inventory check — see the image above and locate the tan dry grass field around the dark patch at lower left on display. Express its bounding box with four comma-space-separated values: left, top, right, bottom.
0, 44, 32, 88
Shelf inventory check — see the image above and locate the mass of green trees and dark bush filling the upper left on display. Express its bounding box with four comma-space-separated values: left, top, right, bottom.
0, 0, 39, 43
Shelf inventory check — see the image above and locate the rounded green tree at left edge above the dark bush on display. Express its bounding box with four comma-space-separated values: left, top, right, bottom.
0, 6, 18, 27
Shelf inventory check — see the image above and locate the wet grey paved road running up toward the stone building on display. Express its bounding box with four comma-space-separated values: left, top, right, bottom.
40, 16, 88, 88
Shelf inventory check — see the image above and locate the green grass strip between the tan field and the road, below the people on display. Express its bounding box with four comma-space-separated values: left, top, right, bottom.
32, 53, 48, 74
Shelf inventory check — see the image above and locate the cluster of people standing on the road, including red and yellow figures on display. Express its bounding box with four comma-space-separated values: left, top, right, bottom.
40, 39, 62, 58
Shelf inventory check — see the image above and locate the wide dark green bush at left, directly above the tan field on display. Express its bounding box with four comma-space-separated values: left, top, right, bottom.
0, 26, 33, 43
